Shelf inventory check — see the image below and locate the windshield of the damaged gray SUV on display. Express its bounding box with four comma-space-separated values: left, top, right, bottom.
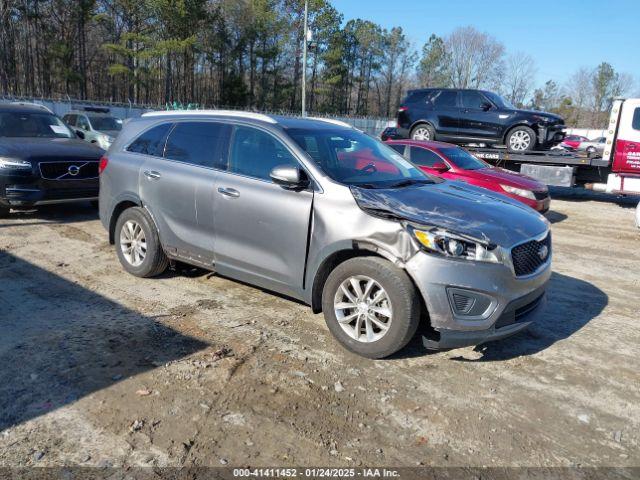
287, 128, 433, 188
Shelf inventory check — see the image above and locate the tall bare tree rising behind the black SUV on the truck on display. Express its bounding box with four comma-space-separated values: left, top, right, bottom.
445, 26, 505, 88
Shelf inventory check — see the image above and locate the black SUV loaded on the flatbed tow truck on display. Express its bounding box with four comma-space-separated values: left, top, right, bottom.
398, 88, 564, 152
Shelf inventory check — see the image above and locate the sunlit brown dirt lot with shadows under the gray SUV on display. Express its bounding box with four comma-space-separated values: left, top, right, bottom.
0, 193, 640, 467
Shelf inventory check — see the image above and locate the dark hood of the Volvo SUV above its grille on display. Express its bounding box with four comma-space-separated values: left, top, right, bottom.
0, 138, 104, 160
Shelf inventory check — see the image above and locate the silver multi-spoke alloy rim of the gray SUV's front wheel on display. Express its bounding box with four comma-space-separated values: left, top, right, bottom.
333, 275, 393, 343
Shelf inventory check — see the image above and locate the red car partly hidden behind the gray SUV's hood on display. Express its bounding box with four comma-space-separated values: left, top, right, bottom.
385, 140, 551, 213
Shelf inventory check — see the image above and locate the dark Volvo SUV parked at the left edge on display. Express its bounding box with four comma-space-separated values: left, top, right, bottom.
0, 103, 104, 217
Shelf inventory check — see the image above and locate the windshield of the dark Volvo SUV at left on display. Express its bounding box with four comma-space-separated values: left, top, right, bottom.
0, 112, 74, 138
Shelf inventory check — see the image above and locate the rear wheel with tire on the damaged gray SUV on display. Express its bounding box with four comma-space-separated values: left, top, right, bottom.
115, 207, 169, 278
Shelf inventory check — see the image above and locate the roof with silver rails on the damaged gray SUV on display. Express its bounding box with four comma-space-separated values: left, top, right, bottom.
142, 110, 353, 128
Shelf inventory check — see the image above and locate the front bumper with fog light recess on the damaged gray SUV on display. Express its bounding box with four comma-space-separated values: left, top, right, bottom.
406, 252, 551, 349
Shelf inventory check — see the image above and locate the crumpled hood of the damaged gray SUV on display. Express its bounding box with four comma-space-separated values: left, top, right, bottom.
351, 181, 549, 247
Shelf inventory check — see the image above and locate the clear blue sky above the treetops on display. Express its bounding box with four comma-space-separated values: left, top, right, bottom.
332, 0, 640, 89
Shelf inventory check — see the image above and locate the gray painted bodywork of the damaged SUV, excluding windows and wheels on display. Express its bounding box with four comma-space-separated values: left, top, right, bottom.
100, 112, 551, 346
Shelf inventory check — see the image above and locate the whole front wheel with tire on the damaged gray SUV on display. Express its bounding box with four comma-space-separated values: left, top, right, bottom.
322, 257, 420, 359
